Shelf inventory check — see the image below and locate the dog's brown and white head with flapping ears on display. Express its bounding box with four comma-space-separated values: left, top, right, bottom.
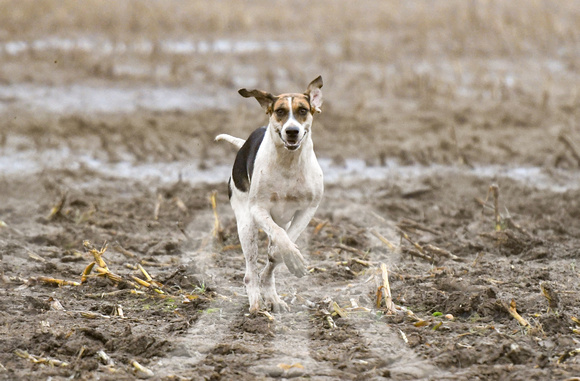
239, 76, 322, 151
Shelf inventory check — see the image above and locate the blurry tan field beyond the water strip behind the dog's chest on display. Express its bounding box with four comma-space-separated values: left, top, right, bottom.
0, 0, 580, 168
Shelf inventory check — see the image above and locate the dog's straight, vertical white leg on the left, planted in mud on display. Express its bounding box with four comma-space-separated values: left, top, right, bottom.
236, 213, 260, 313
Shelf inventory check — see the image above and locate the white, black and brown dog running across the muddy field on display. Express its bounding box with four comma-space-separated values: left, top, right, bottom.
216, 76, 324, 313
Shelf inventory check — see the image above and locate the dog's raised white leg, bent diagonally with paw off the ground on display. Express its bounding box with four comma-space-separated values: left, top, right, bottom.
251, 205, 306, 278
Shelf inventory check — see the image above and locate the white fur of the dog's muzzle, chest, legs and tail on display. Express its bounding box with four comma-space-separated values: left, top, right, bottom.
216, 97, 324, 312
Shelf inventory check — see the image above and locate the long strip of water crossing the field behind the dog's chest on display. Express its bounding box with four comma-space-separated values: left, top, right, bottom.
0, 147, 580, 193
